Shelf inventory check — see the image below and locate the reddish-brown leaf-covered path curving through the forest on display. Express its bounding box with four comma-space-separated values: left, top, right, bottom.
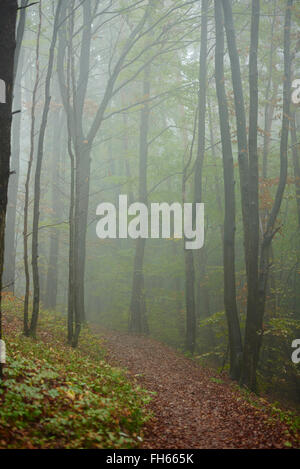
93, 327, 294, 449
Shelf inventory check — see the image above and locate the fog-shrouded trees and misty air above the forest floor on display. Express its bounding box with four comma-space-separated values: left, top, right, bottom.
2, 0, 300, 406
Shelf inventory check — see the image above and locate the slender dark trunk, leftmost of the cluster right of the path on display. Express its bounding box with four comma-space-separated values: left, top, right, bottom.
215, 0, 242, 380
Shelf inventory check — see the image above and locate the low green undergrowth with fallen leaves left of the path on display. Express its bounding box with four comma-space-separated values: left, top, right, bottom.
0, 295, 149, 449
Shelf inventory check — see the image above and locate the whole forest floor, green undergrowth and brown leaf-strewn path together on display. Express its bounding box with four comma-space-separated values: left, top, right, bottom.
0, 295, 300, 449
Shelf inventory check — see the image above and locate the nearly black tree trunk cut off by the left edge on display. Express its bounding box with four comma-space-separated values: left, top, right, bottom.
0, 0, 18, 379
